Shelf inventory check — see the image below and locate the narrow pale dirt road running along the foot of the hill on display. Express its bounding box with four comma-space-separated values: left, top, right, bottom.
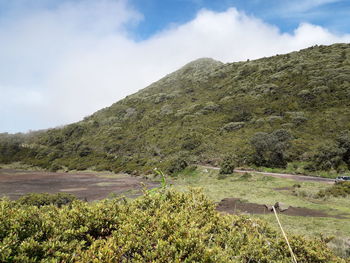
202, 165, 335, 184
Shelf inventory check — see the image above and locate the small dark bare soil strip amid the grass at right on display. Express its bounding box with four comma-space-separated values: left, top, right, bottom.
217, 198, 346, 219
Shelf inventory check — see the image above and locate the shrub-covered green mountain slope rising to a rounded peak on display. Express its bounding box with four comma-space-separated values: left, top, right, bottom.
0, 44, 350, 175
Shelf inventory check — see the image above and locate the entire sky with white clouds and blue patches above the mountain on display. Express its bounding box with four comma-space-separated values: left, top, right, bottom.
0, 0, 350, 133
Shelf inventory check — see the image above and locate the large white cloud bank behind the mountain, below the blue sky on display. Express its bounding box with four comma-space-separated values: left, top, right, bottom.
0, 0, 350, 132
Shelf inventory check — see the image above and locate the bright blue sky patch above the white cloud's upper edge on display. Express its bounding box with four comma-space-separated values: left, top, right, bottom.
131, 0, 350, 38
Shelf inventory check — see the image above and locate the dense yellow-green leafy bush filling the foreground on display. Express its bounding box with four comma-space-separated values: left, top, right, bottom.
0, 190, 344, 263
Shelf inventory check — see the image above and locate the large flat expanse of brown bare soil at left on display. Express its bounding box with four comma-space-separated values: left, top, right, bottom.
0, 169, 158, 201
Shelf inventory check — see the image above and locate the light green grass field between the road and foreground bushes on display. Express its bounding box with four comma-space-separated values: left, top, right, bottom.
173, 167, 350, 256
